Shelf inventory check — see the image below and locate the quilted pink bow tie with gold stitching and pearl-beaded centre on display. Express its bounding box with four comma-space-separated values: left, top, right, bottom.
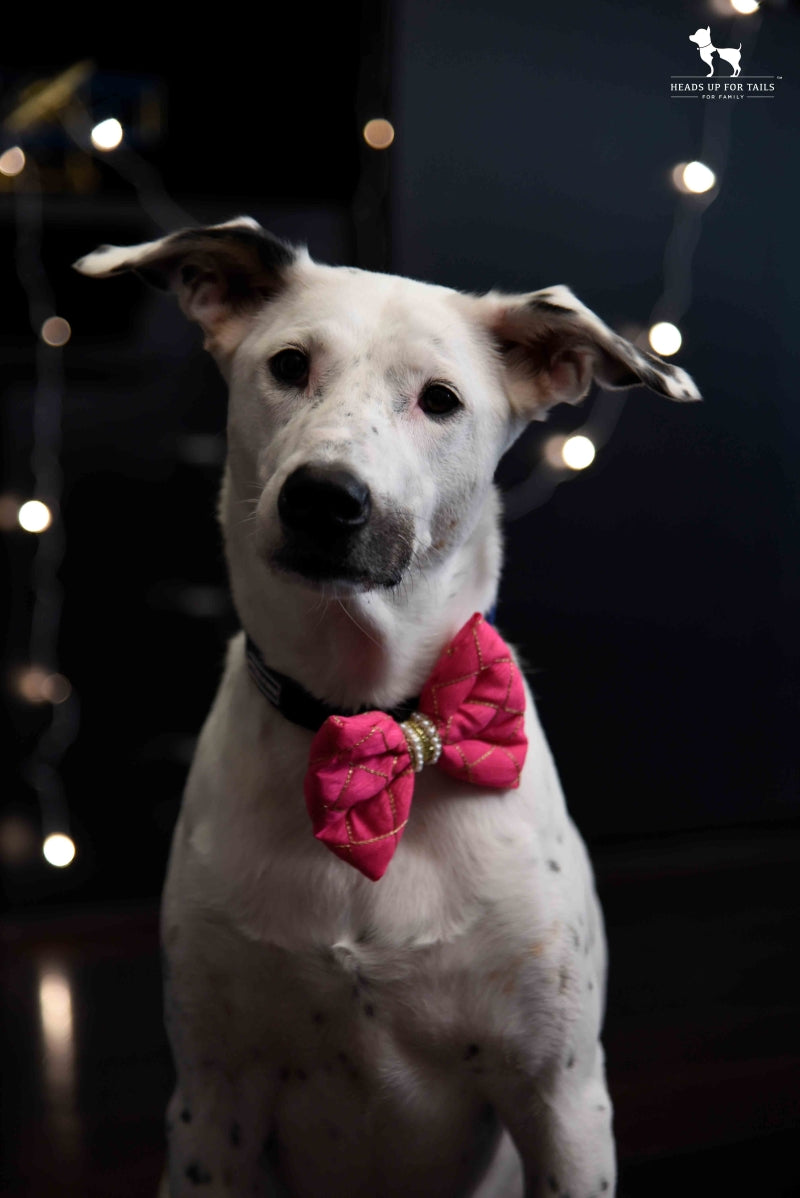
305, 613, 528, 882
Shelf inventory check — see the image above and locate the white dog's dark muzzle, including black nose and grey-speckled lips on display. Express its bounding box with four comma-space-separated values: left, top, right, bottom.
273, 462, 412, 589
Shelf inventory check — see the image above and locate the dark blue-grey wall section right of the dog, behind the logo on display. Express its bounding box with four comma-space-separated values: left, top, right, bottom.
393, 0, 800, 837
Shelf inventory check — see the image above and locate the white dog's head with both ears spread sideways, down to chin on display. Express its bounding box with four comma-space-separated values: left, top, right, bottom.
75, 217, 699, 593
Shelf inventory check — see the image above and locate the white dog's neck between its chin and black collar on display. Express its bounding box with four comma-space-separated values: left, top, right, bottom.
220, 467, 502, 709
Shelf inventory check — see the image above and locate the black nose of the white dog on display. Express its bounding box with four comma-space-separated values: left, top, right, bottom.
278, 464, 372, 537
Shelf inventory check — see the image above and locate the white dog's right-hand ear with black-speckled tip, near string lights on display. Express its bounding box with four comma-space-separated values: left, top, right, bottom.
479, 286, 701, 419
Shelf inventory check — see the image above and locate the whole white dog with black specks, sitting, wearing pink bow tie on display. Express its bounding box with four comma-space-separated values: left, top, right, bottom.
75, 217, 699, 1198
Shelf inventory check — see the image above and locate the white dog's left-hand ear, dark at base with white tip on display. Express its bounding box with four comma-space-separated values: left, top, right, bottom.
73, 217, 298, 357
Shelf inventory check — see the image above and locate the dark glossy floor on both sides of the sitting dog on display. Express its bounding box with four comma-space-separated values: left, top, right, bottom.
0, 829, 800, 1198
